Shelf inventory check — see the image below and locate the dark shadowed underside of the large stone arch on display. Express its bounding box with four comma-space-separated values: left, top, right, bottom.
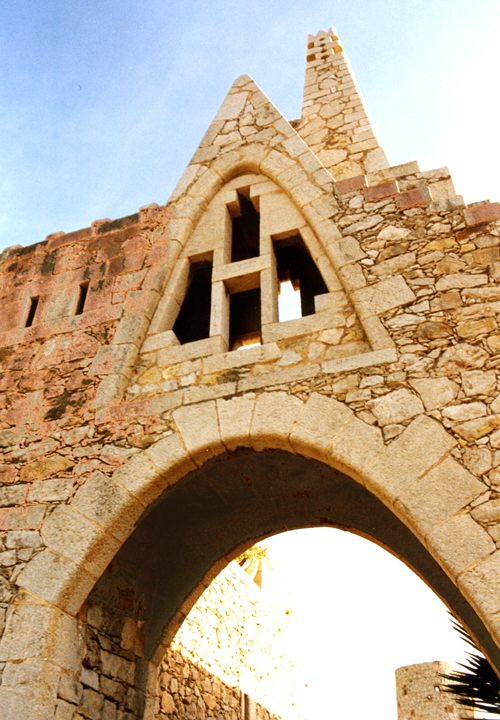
77, 448, 500, 719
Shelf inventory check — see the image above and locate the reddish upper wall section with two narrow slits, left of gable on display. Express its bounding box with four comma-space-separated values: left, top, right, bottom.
0, 205, 171, 347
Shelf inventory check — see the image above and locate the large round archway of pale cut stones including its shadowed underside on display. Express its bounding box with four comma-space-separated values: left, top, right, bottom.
2, 392, 500, 719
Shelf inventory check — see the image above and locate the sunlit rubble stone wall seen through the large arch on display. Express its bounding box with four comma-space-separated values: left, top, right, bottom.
158, 563, 306, 720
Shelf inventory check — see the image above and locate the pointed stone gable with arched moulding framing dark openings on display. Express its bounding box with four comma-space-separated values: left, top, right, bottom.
128, 75, 391, 394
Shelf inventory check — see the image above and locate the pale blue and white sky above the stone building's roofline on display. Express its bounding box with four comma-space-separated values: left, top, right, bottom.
0, 0, 500, 249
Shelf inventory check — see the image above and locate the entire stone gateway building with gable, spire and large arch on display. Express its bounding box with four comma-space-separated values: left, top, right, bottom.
0, 22, 500, 720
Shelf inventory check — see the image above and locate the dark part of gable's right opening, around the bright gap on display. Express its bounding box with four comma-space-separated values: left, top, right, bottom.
274, 235, 328, 317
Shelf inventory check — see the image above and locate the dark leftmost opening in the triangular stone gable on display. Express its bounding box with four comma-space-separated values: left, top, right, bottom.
173, 261, 212, 345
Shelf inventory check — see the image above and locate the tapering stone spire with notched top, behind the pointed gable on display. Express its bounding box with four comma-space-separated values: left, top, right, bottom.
296, 28, 389, 180
